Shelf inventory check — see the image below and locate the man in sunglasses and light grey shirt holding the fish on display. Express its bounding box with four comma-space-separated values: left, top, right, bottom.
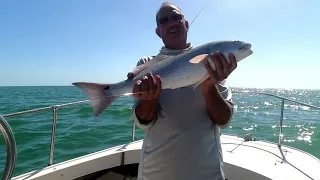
128, 3, 237, 180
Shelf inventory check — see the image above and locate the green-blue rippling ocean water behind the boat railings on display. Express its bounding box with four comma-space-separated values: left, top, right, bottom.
0, 86, 320, 177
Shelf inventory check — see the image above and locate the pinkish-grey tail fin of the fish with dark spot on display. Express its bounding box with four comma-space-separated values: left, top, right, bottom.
72, 82, 119, 117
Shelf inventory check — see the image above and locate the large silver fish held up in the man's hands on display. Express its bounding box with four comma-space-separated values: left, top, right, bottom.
72, 41, 253, 117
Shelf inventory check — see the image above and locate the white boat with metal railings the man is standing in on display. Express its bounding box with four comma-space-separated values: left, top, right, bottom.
0, 91, 320, 180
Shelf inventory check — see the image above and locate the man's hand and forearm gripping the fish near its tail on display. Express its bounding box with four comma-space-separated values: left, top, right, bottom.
127, 72, 162, 123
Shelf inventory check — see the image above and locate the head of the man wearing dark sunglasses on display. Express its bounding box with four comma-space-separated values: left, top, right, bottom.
156, 5, 188, 47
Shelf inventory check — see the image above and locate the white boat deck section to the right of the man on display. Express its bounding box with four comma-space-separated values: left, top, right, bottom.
222, 136, 320, 180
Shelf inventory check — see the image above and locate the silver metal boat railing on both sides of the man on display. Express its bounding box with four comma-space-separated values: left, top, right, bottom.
0, 91, 320, 180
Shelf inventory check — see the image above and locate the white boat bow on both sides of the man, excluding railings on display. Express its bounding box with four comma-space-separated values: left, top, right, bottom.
12, 134, 320, 180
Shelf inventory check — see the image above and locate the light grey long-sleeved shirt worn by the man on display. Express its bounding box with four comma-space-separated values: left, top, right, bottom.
132, 44, 232, 180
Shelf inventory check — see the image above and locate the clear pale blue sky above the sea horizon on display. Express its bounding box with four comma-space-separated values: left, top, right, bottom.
0, 0, 320, 89
